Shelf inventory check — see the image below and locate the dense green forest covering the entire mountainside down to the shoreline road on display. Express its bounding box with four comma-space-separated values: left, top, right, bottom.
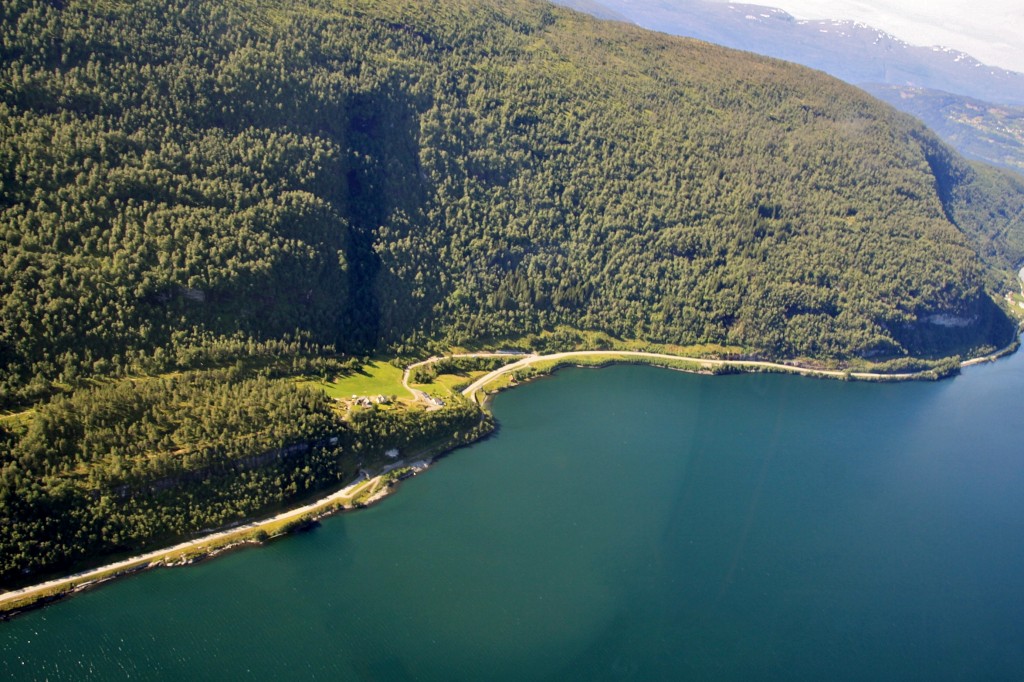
0, 0, 1024, 580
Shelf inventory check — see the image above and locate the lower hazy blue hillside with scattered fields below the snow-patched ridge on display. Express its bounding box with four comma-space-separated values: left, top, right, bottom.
861, 84, 1024, 172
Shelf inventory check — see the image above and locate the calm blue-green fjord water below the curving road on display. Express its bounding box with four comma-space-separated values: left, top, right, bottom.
0, 353, 1024, 680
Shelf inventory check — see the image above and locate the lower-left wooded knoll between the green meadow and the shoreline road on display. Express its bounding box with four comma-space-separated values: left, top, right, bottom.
0, 370, 490, 585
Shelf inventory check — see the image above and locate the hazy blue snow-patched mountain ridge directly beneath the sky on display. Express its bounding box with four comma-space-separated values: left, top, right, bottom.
557, 0, 1024, 105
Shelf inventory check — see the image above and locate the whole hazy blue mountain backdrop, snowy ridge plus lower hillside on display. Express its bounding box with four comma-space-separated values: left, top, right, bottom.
555, 0, 1024, 172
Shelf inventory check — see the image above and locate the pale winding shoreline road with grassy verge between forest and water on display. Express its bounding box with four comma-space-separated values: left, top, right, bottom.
0, 339, 1020, 620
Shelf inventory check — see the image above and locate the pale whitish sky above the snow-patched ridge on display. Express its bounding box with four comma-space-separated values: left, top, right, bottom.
740, 0, 1024, 72
